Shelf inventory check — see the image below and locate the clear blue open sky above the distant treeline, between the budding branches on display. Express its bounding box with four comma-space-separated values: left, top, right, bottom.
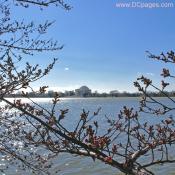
14, 0, 175, 92
